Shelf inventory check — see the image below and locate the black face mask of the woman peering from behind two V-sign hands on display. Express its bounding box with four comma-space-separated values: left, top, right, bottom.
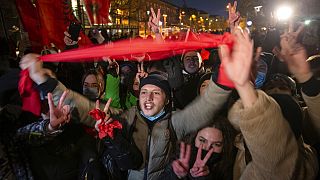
189, 145, 222, 167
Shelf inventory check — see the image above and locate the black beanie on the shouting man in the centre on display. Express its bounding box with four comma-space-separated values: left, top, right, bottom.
139, 72, 171, 99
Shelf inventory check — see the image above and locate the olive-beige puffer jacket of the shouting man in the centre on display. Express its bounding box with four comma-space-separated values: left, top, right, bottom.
48, 81, 231, 179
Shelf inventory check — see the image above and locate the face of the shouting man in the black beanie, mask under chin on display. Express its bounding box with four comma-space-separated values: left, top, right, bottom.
139, 84, 166, 116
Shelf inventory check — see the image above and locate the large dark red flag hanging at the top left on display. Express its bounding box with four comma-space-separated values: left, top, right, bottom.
16, 0, 91, 53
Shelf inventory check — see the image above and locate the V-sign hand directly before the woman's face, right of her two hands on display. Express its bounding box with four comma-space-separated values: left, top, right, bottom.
190, 144, 213, 177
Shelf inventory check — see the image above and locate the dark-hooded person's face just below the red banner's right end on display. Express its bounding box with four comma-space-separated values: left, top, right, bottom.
183, 51, 201, 74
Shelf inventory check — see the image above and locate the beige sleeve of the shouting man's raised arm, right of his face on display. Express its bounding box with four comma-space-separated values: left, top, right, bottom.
172, 81, 231, 140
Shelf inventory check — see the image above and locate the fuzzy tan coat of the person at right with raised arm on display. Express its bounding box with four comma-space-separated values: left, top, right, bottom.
228, 91, 318, 180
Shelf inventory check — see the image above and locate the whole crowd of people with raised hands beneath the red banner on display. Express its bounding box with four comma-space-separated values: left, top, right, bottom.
0, 4, 320, 180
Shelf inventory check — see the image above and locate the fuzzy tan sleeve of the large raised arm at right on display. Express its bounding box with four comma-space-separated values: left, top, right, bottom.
232, 91, 299, 179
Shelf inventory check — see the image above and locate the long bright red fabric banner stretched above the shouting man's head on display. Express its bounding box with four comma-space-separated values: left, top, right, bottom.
40, 33, 233, 62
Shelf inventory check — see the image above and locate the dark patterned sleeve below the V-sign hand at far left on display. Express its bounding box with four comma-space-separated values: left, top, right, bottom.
15, 119, 62, 145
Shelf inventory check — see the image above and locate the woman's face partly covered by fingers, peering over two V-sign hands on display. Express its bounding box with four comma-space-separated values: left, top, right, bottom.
195, 127, 223, 153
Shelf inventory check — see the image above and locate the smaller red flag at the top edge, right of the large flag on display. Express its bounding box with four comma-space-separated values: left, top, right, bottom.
84, 0, 110, 25
